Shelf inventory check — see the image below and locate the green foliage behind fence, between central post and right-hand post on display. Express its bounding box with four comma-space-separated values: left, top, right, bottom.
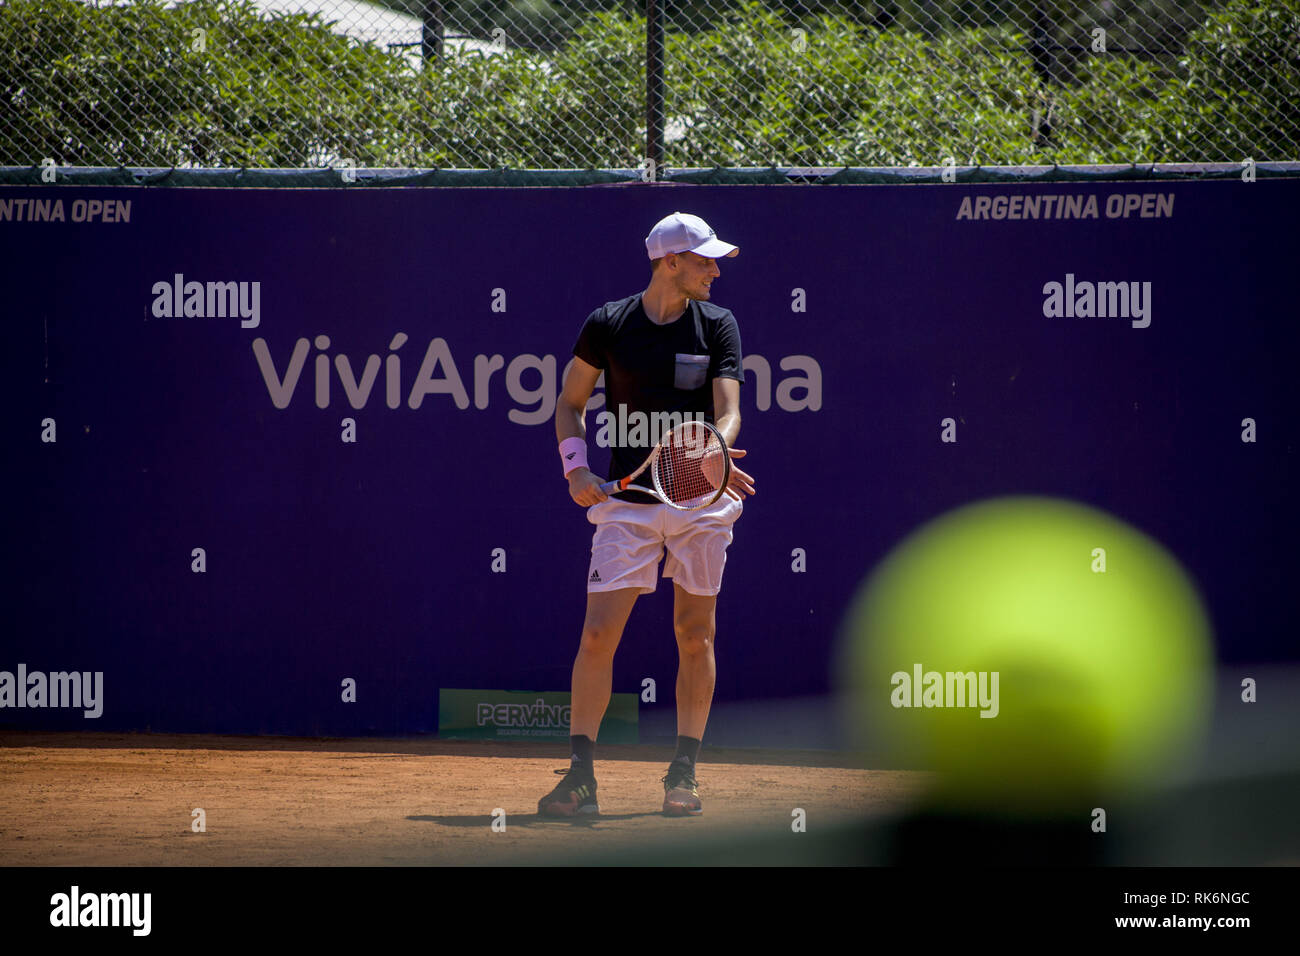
668, 5, 1032, 165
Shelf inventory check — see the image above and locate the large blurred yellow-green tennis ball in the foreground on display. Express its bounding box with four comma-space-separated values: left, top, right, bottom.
841, 498, 1210, 813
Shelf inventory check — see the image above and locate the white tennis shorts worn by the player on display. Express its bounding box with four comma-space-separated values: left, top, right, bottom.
586, 494, 744, 597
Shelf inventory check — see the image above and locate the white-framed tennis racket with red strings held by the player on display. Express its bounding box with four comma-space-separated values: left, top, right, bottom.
601, 421, 731, 511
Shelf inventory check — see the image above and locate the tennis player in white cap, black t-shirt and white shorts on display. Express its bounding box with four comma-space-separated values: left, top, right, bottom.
537, 212, 754, 817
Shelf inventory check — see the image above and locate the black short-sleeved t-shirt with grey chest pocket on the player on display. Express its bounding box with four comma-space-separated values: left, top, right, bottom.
573, 293, 745, 502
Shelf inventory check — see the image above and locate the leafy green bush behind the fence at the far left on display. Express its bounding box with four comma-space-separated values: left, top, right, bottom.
0, 0, 413, 166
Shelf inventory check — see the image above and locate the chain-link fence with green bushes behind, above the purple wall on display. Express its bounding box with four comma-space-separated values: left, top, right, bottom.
0, 0, 1300, 170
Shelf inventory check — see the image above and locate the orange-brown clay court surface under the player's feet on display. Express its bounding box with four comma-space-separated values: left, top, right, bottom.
0, 732, 924, 866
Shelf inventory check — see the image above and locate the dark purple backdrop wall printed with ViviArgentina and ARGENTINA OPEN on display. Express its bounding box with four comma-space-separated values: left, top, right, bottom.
0, 181, 1300, 735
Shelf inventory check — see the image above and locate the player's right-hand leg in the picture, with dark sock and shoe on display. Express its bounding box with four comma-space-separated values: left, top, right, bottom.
663, 581, 718, 816
